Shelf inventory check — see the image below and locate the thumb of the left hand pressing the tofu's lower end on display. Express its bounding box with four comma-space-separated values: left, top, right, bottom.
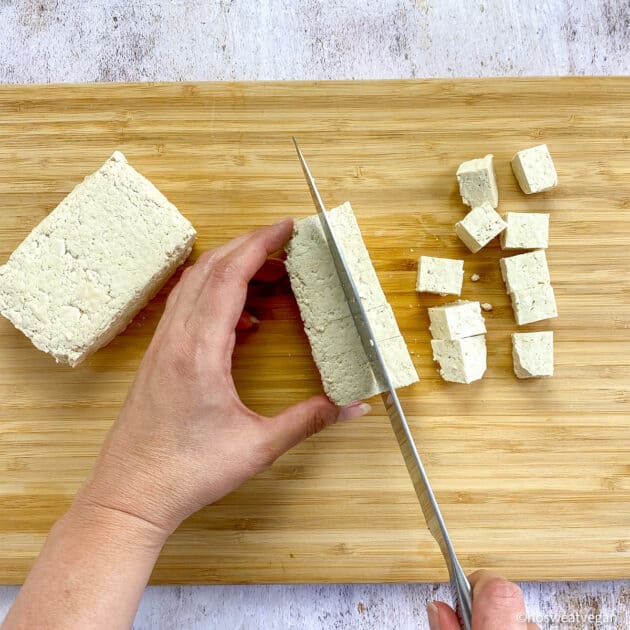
271, 396, 371, 456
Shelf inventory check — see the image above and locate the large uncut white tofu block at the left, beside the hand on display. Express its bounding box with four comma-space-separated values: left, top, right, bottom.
0, 151, 196, 366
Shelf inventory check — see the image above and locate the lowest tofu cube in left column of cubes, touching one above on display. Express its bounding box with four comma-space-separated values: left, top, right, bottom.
431, 335, 487, 384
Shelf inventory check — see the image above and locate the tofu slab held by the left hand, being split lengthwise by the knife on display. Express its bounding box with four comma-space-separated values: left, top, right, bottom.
286, 202, 418, 405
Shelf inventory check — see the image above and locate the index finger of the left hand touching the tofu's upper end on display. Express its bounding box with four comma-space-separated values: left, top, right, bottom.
191, 219, 293, 336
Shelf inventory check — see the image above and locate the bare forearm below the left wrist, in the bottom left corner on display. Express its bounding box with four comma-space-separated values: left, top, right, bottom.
3, 496, 165, 630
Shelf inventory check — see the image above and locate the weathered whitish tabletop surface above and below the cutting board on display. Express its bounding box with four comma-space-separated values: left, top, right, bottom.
0, 0, 630, 630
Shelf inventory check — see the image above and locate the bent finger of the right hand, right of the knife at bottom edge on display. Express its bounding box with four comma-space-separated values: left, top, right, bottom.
469, 570, 535, 630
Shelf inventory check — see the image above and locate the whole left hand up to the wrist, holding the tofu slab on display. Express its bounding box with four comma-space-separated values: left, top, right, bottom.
77, 219, 369, 537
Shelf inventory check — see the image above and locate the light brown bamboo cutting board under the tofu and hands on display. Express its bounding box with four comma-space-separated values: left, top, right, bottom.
0, 79, 630, 583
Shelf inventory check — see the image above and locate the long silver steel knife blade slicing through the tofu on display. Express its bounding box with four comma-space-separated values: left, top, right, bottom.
293, 138, 472, 630
